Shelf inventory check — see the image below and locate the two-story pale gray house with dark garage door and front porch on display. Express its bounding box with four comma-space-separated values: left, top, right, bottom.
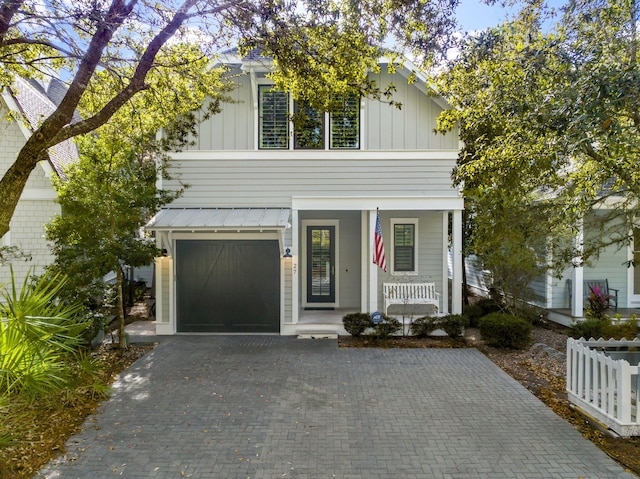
148, 52, 463, 335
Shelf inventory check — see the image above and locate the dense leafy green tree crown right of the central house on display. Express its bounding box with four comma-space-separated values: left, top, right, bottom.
438, 0, 640, 290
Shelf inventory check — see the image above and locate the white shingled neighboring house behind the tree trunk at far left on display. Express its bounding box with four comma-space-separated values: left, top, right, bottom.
0, 78, 78, 284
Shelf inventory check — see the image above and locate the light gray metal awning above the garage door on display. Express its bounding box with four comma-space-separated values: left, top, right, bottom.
146, 208, 291, 231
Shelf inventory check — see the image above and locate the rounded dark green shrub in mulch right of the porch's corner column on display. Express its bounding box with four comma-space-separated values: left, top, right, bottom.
480, 313, 533, 349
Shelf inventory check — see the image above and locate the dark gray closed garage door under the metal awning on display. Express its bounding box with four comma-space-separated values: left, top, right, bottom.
176, 240, 280, 333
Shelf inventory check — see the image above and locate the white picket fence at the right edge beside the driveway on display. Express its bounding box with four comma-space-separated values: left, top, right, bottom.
567, 338, 640, 437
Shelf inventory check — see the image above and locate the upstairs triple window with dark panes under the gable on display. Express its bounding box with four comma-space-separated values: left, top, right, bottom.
258, 85, 360, 150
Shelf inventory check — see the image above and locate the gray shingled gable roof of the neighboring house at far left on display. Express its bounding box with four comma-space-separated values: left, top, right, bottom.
2, 77, 78, 177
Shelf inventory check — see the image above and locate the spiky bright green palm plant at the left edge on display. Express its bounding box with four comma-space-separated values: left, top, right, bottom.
0, 270, 87, 398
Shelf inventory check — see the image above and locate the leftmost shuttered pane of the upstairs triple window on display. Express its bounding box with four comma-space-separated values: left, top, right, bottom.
259, 86, 289, 149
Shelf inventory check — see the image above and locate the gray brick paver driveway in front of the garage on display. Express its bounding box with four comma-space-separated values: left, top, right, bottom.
38, 336, 636, 479
